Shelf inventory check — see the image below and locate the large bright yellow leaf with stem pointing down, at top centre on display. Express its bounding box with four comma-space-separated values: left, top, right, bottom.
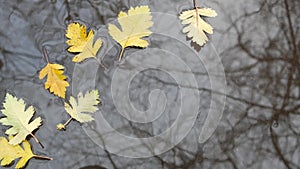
108, 6, 153, 61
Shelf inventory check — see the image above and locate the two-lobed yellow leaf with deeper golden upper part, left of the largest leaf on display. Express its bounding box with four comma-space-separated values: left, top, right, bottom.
66, 23, 102, 62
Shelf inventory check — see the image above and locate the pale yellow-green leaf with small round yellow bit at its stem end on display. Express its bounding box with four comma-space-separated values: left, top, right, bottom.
57, 90, 100, 130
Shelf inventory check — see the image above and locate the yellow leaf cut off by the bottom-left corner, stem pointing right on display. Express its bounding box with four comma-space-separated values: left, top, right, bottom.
0, 136, 52, 169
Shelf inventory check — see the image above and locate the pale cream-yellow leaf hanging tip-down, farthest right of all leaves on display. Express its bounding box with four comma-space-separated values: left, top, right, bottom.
179, 8, 217, 46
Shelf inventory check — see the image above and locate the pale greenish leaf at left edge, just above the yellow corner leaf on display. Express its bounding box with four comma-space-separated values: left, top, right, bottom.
0, 93, 43, 147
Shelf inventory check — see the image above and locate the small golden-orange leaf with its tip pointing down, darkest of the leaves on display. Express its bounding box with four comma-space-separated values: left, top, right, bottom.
39, 63, 69, 98
